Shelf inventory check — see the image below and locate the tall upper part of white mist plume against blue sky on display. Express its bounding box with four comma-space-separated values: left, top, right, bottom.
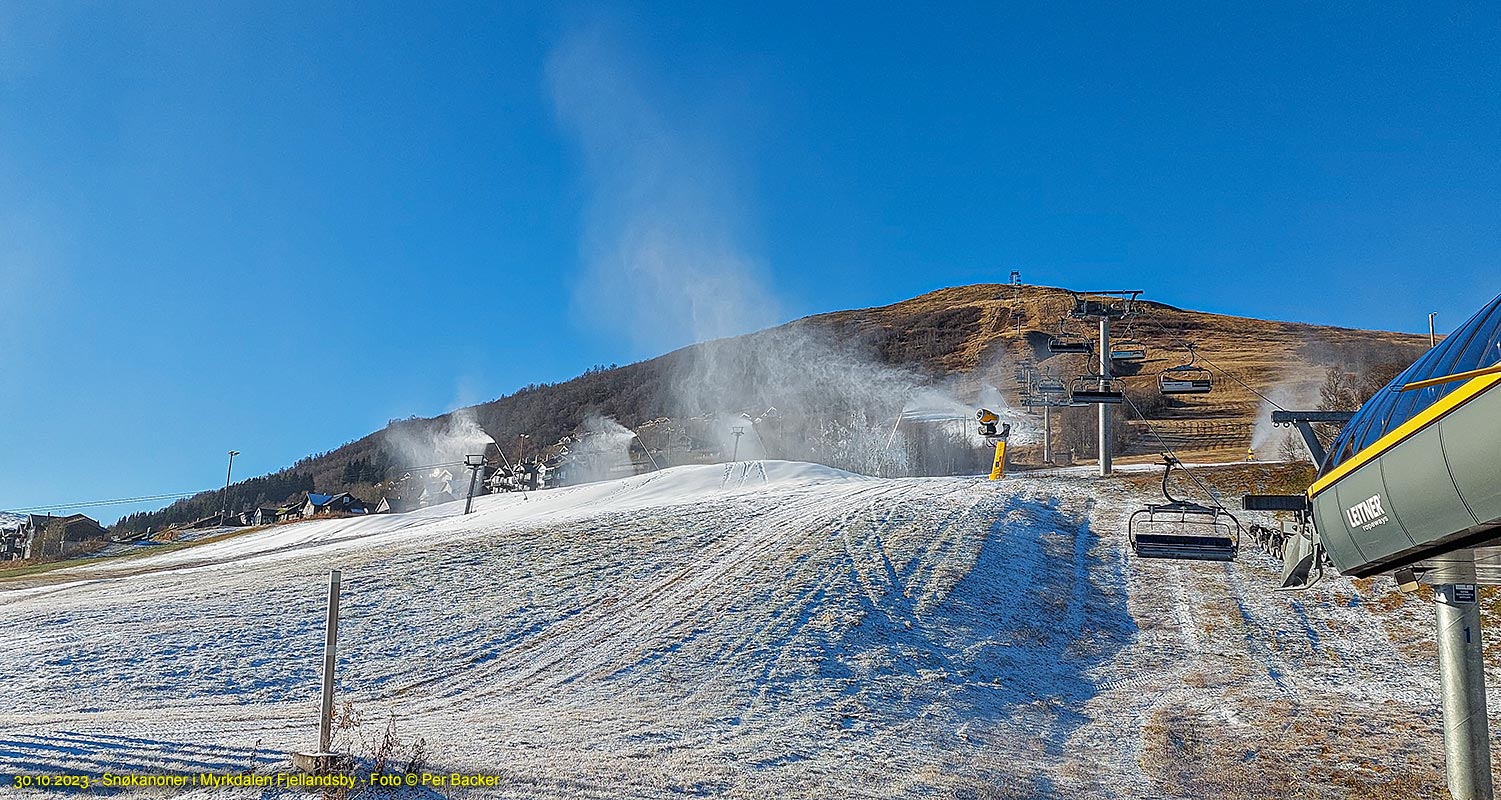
548, 27, 776, 350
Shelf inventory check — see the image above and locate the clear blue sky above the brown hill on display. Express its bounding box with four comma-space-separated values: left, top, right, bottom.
0, 0, 1501, 519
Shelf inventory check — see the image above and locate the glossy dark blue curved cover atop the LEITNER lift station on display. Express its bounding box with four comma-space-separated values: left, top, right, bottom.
1319, 297, 1501, 474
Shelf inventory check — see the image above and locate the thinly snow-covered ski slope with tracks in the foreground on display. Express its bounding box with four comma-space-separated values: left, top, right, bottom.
0, 461, 1464, 798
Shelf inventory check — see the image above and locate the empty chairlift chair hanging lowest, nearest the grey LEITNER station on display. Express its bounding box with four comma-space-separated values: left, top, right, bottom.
1126, 456, 1241, 561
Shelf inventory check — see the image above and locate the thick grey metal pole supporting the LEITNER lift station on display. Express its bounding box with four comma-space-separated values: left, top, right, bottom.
1433, 584, 1493, 800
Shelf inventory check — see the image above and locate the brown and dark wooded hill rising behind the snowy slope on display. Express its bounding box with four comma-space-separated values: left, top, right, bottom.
117, 284, 1427, 530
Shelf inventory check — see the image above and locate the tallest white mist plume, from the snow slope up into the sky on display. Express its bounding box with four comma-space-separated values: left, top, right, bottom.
548, 27, 974, 474
